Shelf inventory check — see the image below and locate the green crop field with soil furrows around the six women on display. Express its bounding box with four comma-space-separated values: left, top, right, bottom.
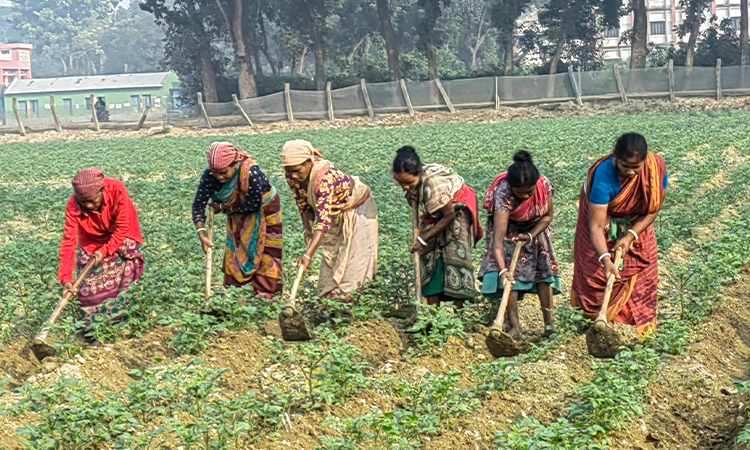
0, 111, 750, 450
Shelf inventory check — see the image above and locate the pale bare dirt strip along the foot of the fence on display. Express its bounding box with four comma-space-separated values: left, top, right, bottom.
0, 97, 750, 144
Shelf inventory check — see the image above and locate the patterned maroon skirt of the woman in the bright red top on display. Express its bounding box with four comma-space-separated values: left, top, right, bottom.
76, 239, 144, 326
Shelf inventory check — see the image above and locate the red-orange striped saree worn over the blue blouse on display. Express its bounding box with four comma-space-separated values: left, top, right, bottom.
570, 152, 667, 336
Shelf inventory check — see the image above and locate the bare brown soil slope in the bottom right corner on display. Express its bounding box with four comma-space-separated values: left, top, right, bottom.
612, 274, 750, 450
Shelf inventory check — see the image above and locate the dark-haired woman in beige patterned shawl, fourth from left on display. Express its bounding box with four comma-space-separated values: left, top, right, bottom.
393, 146, 484, 309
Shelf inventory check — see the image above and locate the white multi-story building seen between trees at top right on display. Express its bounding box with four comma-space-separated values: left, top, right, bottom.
604, 0, 740, 59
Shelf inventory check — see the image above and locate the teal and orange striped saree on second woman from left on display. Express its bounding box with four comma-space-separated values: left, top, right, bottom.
212, 158, 283, 298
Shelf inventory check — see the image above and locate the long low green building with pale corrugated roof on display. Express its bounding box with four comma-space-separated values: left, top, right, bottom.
4, 72, 181, 123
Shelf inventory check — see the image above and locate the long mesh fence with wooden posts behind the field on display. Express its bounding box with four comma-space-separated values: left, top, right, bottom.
0, 60, 750, 133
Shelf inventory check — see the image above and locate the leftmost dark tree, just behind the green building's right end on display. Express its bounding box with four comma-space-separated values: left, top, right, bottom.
140, 0, 219, 103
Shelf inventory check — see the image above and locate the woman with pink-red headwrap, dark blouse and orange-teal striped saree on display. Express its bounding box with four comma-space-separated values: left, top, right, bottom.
193, 142, 283, 298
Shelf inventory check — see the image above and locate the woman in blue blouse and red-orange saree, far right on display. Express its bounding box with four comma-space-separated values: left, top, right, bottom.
571, 133, 667, 336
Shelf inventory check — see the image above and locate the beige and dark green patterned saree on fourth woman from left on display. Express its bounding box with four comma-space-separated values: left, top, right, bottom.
416, 164, 484, 300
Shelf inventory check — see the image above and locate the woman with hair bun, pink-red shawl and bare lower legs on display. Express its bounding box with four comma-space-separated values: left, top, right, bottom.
479, 151, 561, 339
